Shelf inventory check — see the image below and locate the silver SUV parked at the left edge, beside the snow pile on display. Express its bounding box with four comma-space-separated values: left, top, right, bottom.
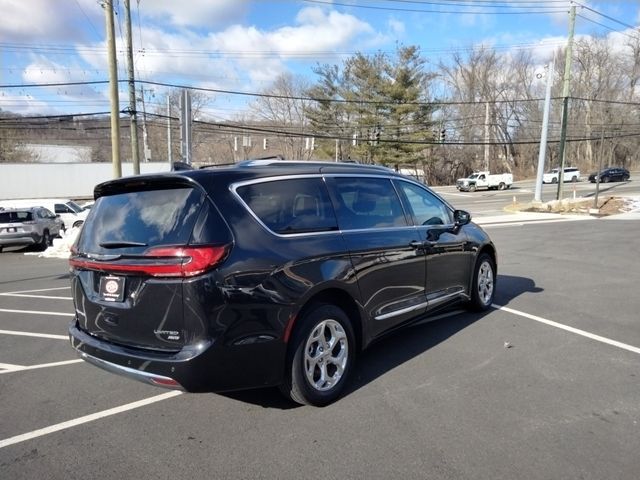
0, 207, 62, 252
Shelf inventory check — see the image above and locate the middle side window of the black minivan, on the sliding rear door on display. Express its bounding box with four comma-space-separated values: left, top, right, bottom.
331, 177, 407, 230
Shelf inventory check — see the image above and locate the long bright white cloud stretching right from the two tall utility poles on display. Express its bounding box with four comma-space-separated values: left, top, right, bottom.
77, 8, 375, 90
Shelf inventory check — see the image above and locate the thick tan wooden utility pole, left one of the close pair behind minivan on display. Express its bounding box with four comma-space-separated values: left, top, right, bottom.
102, 0, 122, 178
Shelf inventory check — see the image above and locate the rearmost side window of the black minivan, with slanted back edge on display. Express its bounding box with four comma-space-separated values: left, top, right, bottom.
236, 177, 338, 235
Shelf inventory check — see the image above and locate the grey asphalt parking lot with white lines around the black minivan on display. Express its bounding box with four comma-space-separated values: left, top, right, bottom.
0, 215, 640, 480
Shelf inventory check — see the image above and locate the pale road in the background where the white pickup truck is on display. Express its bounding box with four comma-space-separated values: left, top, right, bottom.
432, 172, 640, 216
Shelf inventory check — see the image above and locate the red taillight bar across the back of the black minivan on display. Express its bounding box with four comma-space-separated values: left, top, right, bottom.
69, 245, 228, 277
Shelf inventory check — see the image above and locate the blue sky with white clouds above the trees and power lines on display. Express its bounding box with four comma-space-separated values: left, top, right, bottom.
0, 0, 640, 119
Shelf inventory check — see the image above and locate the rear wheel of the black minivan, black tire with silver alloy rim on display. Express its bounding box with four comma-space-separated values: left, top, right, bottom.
280, 304, 356, 407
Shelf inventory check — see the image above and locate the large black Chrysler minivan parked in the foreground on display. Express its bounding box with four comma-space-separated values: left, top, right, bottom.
69, 161, 496, 405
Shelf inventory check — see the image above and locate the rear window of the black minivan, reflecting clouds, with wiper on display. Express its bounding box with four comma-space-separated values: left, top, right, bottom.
77, 188, 204, 254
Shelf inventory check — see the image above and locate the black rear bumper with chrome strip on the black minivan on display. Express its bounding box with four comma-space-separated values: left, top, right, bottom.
69, 321, 286, 392
